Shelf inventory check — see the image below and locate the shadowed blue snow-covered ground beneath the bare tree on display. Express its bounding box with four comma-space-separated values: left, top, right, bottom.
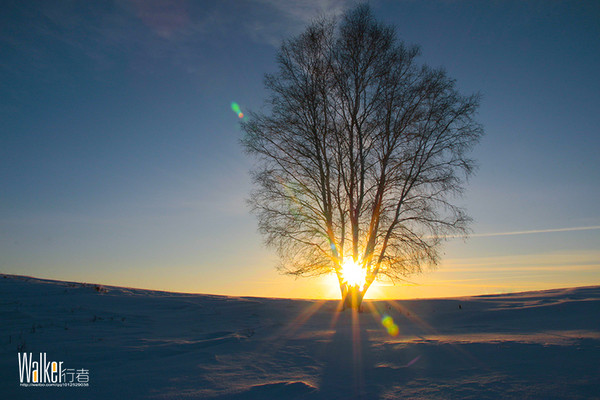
0, 275, 600, 400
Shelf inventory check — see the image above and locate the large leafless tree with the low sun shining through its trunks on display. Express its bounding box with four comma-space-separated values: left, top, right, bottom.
242, 6, 483, 308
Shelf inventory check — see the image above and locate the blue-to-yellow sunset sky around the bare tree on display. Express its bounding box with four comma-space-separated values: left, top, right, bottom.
0, 0, 600, 298
